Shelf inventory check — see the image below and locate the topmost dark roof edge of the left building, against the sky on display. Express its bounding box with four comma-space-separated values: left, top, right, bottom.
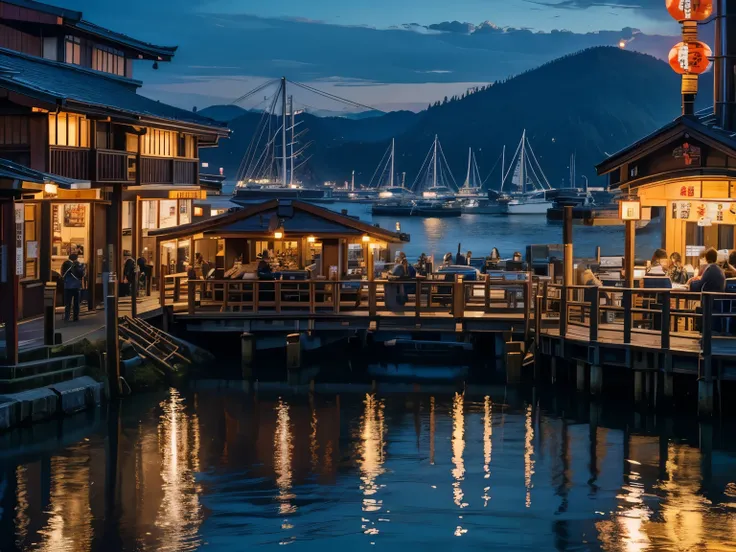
2, 0, 177, 61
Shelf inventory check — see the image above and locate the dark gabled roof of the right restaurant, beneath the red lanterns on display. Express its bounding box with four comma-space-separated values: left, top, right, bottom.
595, 109, 736, 176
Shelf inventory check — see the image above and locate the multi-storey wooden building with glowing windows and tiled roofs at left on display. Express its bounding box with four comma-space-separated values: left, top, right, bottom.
0, 0, 228, 362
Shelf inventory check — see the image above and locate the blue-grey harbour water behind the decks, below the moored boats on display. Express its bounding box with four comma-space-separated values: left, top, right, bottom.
208, 196, 662, 259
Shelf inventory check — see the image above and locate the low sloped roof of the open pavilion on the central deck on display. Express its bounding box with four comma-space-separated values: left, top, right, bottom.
148, 199, 409, 243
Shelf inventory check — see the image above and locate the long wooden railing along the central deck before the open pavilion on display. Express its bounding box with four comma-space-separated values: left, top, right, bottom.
161, 274, 537, 331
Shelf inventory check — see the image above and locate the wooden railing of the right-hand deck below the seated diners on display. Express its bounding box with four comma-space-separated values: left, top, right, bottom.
536, 284, 736, 357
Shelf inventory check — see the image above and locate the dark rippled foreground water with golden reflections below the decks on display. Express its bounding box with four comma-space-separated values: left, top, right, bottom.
0, 388, 736, 552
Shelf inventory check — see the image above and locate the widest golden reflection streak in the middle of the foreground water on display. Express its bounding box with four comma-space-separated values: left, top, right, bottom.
358, 394, 386, 535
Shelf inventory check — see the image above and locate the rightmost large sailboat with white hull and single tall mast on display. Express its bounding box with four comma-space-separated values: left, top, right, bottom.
501, 130, 553, 215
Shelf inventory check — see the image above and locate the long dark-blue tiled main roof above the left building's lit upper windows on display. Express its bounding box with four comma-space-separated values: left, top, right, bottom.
0, 48, 228, 136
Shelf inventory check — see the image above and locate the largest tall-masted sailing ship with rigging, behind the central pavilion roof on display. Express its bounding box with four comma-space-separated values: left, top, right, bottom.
232, 78, 326, 205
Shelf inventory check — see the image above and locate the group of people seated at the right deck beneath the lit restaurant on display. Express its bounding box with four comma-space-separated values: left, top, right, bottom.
642, 247, 736, 292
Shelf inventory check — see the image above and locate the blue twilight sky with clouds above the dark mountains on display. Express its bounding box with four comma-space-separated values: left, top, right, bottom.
59, 0, 678, 111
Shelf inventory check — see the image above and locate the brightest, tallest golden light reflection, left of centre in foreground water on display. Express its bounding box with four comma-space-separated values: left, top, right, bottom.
152, 389, 203, 552
